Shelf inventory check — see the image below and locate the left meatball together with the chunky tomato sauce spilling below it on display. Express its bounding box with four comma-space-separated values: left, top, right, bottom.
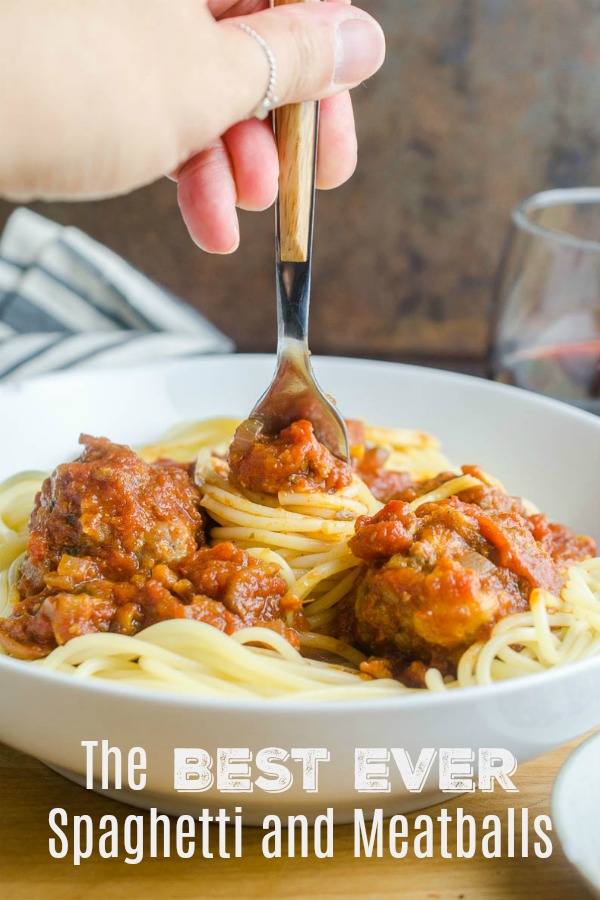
0, 437, 306, 659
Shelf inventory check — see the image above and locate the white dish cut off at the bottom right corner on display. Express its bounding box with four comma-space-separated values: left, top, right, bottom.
552, 734, 600, 897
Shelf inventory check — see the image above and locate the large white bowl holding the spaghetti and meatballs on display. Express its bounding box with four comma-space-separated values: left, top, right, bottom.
0, 356, 600, 824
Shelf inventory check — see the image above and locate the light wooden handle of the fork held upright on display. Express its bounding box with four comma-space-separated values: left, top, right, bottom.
273, 0, 319, 262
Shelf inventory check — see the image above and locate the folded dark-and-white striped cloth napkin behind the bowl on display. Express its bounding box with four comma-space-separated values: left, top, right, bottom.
0, 209, 234, 380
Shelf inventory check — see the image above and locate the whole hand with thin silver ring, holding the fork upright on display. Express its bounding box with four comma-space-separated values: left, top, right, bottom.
0, 0, 384, 253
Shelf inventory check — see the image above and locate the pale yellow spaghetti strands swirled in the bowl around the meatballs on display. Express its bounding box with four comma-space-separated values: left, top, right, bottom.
0, 419, 600, 701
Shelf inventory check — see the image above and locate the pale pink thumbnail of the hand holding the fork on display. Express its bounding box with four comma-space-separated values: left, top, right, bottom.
333, 19, 385, 84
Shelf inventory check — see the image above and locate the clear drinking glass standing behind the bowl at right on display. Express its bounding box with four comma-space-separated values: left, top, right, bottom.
491, 188, 600, 414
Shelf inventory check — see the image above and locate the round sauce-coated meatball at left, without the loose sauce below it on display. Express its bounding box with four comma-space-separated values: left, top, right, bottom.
20, 435, 204, 596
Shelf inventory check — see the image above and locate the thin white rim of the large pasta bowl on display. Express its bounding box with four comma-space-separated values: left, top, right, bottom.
0, 353, 600, 716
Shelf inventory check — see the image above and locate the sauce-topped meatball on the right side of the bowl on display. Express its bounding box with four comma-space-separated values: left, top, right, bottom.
337, 486, 576, 677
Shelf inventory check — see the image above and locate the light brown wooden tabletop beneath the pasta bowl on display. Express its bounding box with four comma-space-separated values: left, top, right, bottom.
0, 741, 588, 900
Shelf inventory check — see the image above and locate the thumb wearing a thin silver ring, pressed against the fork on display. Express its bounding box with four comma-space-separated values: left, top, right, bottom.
213, 2, 385, 124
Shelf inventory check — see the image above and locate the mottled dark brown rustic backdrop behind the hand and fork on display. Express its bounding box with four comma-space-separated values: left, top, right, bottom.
0, 0, 600, 366
